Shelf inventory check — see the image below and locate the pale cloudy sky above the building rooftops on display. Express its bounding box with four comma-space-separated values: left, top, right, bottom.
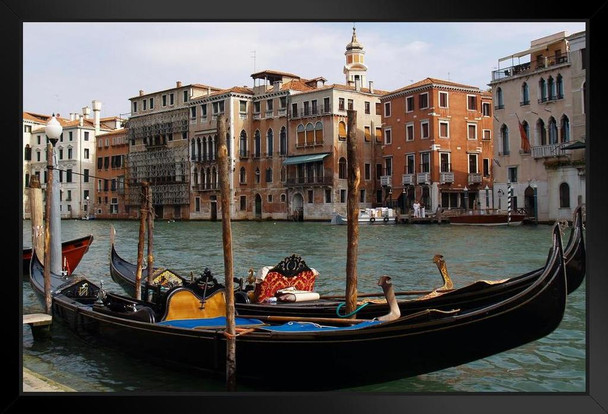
23, 21, 585, 117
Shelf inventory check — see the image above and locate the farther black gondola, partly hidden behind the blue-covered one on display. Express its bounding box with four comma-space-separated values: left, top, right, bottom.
110, 206, 586, 318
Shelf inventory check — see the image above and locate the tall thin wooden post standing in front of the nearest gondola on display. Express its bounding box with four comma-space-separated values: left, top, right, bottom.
217, 114, 236, 391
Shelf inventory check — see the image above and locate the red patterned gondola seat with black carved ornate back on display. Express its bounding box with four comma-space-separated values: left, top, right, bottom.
253, 254, 319, 303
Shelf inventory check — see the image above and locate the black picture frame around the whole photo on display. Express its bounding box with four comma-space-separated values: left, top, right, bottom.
7, 0, 608, 414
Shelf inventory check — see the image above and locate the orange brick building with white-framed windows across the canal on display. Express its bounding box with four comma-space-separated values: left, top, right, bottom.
380, 78, 493, 213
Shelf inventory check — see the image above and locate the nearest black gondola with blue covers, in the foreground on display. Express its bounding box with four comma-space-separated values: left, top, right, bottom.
30, 225, 567, 390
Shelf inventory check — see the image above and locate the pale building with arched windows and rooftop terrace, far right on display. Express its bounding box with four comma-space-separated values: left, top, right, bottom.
490, 32, 585, 221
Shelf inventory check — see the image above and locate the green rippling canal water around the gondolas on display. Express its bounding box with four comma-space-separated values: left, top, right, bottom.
22, 220, 586, 393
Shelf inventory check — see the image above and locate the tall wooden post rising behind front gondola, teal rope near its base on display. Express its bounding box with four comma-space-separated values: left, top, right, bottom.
345, 110, 361, 316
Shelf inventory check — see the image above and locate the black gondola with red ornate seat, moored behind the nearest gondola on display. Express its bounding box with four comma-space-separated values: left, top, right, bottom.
110, 208, 586, 318
